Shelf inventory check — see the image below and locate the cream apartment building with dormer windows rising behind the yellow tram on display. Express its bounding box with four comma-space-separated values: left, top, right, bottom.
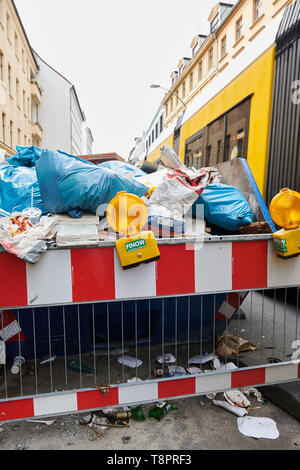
162, 0, 294, 127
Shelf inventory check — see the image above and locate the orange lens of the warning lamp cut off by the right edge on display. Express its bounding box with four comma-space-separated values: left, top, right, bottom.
270, 188, 300, 230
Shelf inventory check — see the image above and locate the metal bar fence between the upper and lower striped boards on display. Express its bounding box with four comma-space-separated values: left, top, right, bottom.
0, 288, 300, 408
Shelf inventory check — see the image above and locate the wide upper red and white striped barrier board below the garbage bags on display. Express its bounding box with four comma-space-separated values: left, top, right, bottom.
0, 240, 300, 314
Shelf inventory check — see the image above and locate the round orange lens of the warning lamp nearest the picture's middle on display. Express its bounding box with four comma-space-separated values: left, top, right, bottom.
106, 191, 148, 236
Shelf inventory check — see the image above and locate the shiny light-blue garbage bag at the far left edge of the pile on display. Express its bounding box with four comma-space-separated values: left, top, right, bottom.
0, 165, 48, 214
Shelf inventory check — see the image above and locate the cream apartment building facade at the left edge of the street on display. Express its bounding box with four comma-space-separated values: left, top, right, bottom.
0, 0, 43, 155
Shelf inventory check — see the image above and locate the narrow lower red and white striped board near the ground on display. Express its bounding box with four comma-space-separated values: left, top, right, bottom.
0, 361, 300, 422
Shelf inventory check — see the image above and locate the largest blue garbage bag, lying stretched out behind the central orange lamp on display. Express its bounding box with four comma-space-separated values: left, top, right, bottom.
36, 150, 148, 218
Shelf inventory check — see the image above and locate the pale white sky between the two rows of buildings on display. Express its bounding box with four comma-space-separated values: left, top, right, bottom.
15, 0, 235, 158
